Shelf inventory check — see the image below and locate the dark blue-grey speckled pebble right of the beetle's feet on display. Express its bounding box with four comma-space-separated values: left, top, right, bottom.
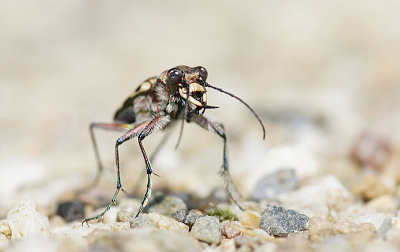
260, 205, 310, 236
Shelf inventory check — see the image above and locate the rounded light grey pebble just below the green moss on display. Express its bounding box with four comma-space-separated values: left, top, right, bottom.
191, 216, 222, 244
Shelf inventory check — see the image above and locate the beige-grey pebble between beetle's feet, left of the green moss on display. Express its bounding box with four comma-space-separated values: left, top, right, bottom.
147, 196, 187, 217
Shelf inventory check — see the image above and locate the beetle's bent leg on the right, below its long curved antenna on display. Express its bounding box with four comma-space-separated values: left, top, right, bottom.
188, 114, 244, 211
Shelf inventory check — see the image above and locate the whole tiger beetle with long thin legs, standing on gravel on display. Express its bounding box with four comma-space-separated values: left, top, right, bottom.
82, 66, 265, 225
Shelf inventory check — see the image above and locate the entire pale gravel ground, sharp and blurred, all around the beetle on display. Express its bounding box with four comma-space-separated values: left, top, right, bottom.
0, 0, 400, 251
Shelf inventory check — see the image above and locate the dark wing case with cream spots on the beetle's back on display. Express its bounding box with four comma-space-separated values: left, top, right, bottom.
114, 77, 157, 124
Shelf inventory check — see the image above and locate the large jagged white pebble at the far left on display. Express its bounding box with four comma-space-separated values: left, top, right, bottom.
7, 199, 50, 238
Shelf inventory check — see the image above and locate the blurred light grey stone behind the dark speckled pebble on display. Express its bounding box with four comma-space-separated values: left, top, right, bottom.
250, 169, 299, 200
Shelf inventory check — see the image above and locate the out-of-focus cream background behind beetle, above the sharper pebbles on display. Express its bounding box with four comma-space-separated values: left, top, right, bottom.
0, 0, 400, 218
